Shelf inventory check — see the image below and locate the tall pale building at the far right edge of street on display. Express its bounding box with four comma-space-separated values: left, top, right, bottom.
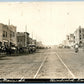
74, 26, 84, 46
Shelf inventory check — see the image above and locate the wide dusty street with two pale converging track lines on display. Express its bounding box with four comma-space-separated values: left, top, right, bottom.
0, 48, 84, 79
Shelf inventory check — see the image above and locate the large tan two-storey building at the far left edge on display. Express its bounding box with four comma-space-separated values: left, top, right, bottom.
0, 23, 17, 46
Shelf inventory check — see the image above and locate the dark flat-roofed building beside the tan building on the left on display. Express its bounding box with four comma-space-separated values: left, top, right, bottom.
17, 32, 29, 47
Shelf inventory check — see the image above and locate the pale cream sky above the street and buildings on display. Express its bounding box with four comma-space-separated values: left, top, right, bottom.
0, 1, 84, 45
